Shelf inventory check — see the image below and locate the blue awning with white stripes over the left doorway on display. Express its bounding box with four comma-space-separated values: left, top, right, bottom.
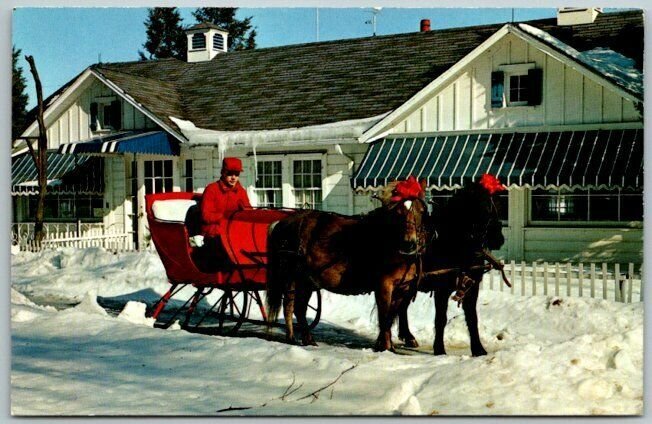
58, 131, 179, 156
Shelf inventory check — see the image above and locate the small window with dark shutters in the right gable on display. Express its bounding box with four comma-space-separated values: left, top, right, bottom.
491, 63, 543, 108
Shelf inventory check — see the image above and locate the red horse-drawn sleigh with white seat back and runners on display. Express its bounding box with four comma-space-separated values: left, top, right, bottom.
146, 192, 321, 335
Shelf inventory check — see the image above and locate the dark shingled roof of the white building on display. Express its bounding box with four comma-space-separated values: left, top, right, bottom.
77, 10, 643, 131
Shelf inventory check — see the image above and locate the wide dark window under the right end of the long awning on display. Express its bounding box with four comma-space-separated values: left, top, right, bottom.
531, 189, 643, 222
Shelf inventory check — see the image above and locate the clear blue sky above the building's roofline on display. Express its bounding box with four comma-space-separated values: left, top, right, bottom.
12, 7, 556, 108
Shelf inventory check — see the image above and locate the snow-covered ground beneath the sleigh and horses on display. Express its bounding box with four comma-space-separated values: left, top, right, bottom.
11, 249, 643, 415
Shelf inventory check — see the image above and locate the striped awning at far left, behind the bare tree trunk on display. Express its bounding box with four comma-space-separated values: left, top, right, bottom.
11, 151, 104, 196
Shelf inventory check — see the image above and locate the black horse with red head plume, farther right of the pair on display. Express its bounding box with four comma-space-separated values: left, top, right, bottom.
399, 174, 505, 356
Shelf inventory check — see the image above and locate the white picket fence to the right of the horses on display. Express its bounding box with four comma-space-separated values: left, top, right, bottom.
481, 261, 643, 303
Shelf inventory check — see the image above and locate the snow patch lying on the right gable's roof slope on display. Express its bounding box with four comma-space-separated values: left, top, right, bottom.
518, 24, 643, 98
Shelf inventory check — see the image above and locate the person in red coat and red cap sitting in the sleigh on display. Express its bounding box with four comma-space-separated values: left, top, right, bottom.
201, 158, 251, 269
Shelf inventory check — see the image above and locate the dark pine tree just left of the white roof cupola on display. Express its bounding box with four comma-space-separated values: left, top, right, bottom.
138, 7, 186, 61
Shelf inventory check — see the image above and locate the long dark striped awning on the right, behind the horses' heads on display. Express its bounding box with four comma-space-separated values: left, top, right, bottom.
351, 129, 643, 190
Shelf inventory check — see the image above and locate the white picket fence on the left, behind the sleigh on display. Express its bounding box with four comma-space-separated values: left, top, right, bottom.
12, 223, 135, 252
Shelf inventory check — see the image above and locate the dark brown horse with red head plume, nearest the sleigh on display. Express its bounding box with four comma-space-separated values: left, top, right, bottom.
267, 178, 427, 351
